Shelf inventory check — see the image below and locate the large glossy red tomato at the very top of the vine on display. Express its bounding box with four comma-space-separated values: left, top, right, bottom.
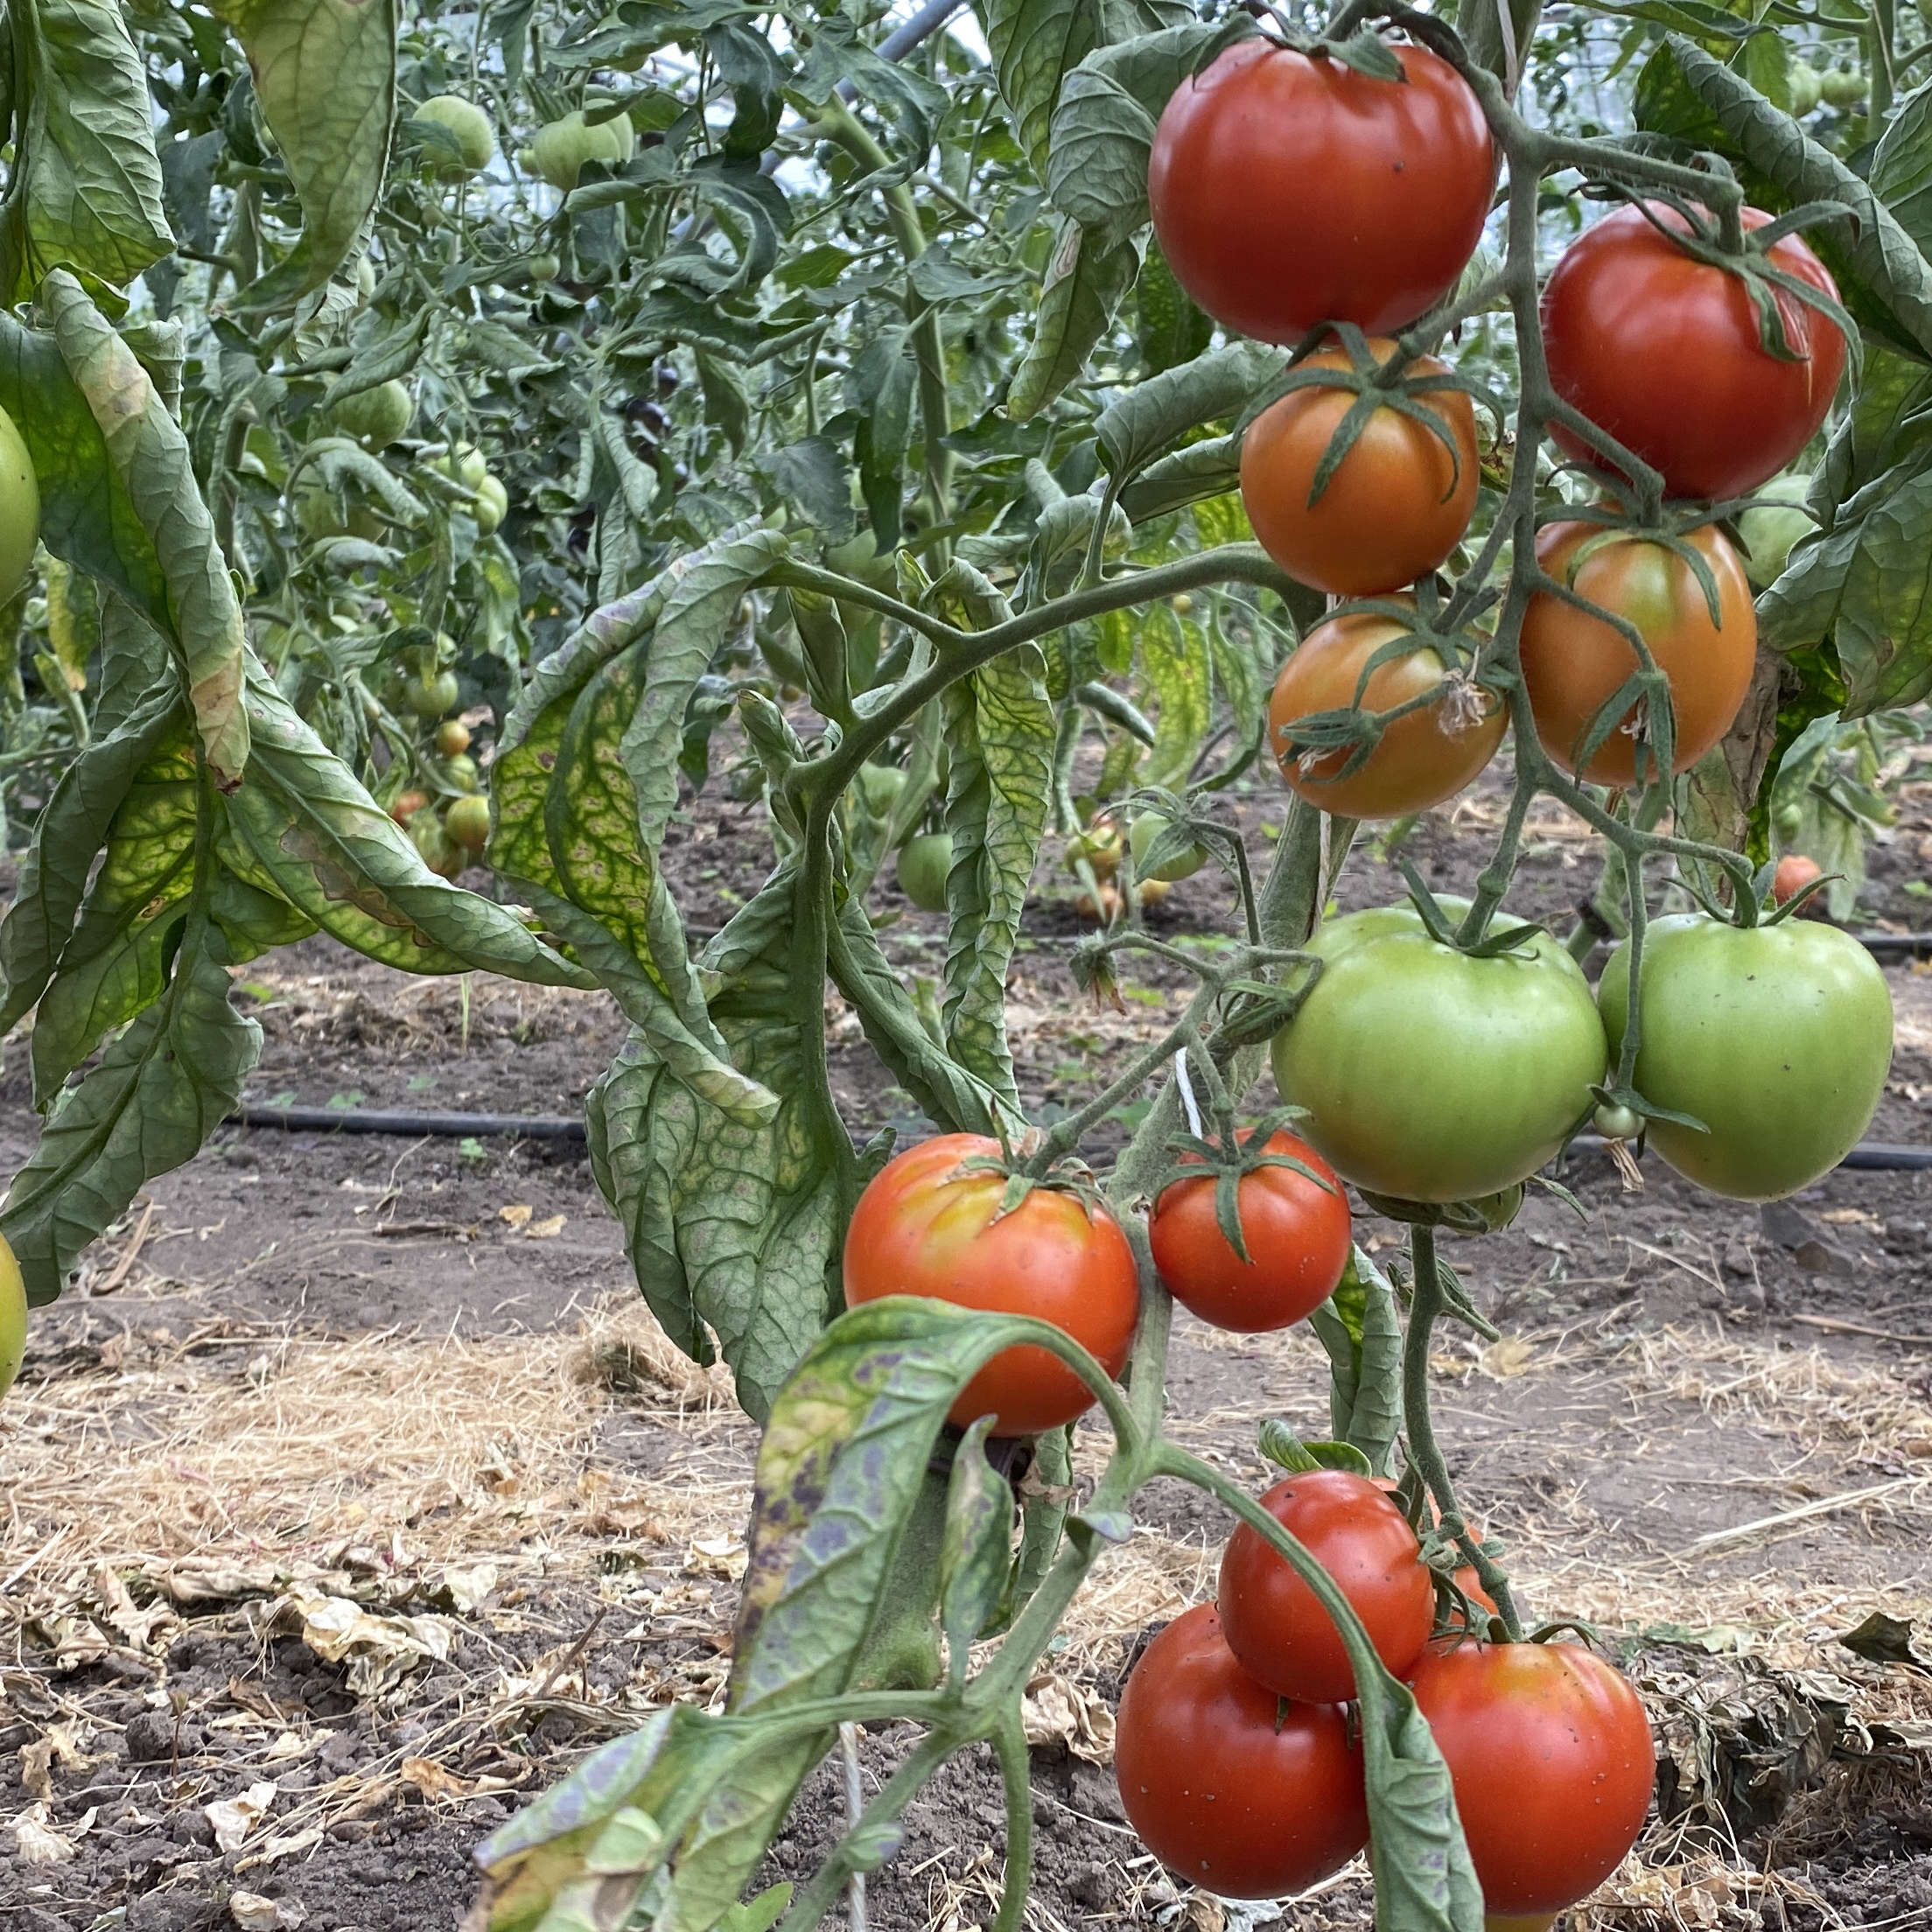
1148, 37, 1495, 342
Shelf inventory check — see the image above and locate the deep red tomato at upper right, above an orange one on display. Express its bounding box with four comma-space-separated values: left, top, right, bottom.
1544, 201, 1845, 500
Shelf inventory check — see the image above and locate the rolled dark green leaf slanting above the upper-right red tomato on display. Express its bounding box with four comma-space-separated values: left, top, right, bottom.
1636, 33, 1932, 360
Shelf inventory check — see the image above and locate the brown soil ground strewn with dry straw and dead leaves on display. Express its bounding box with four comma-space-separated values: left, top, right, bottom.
0, 749, 1932, 1932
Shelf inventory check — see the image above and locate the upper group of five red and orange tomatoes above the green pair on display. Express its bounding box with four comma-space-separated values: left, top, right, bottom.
1150, 37, 1845, 817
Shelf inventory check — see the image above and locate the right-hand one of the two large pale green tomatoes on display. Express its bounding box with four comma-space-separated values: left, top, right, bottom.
1598, 912, 1892, 1201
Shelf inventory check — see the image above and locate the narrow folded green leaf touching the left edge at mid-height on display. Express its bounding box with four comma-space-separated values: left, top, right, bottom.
0, 688, 179, 1033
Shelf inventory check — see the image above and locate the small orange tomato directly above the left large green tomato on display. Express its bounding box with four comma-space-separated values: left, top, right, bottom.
1267, 612, 1503, 819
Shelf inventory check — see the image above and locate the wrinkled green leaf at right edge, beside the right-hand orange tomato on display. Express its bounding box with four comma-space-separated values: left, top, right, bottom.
1758, 456, 1932, 717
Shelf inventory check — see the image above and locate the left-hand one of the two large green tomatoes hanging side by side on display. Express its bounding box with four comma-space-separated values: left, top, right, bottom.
1273, 899, 1606, 1201
